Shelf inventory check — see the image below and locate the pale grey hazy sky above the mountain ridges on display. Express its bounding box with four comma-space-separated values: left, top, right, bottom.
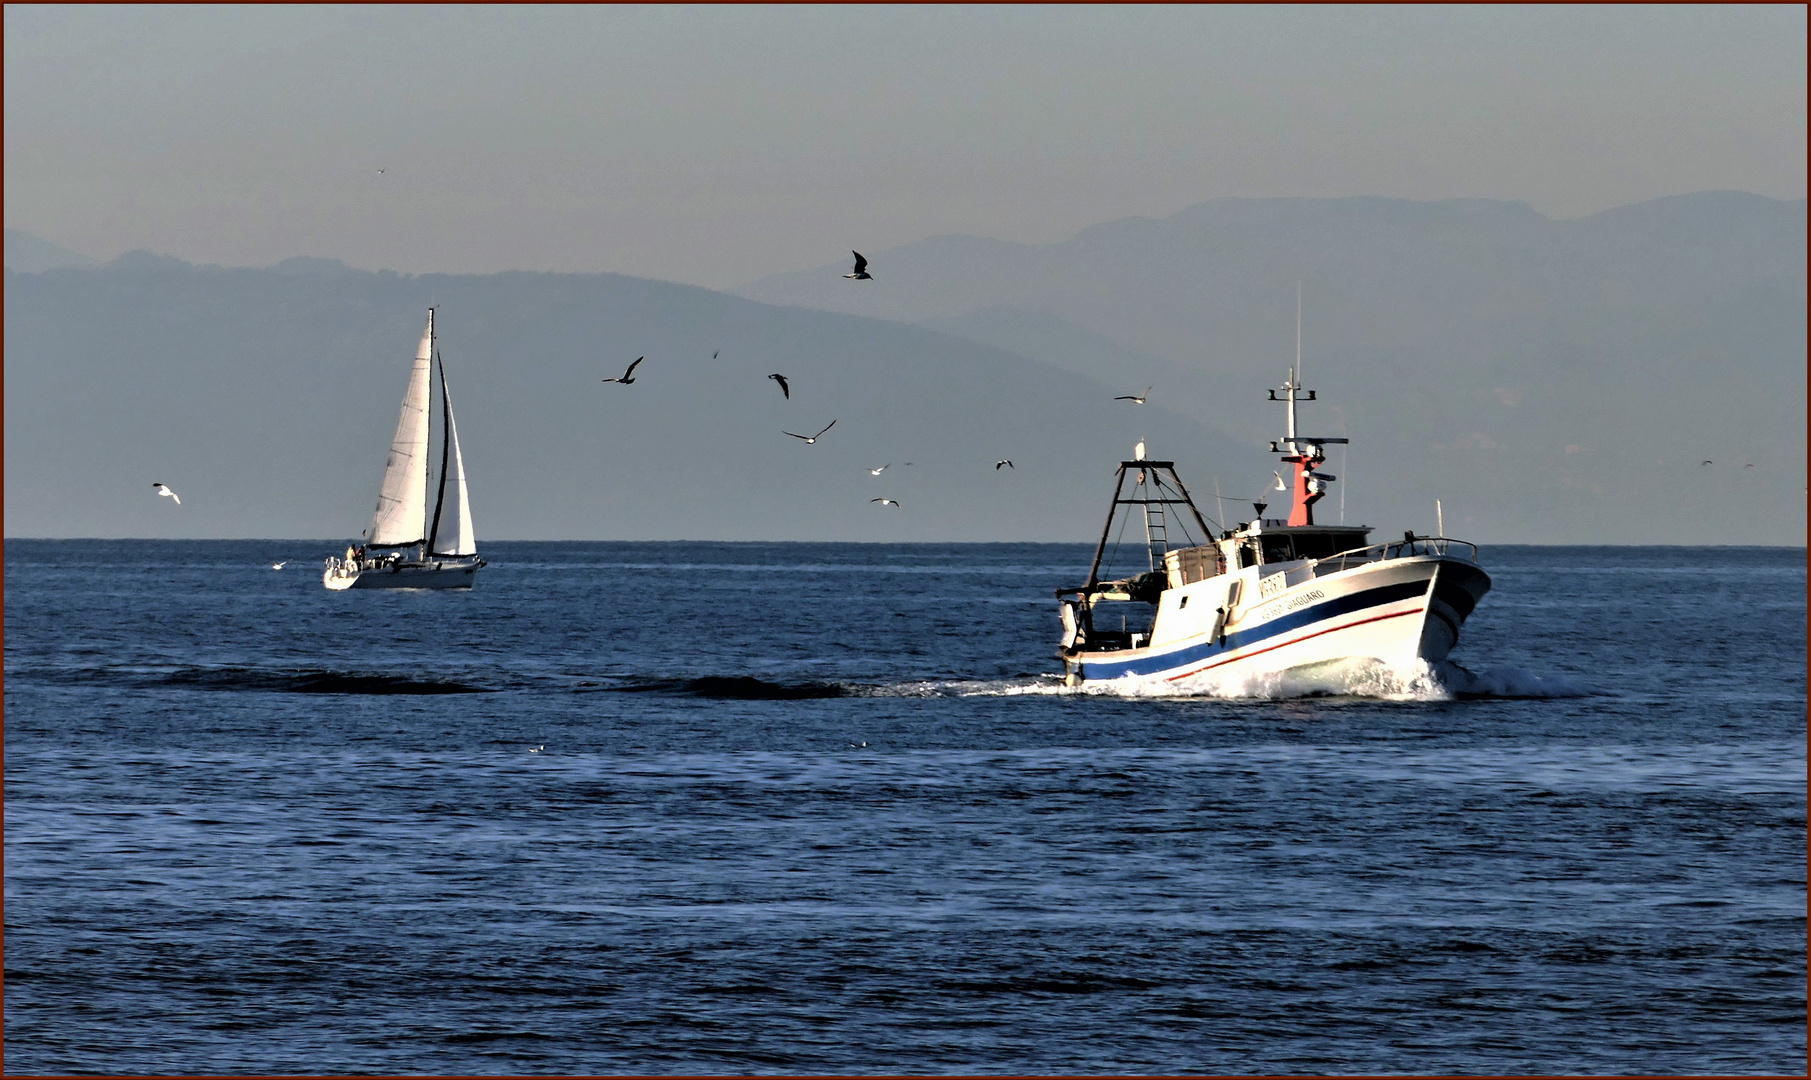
5, 5, 1807, 288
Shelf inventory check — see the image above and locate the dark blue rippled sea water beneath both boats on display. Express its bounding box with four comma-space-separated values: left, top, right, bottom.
5, 540, 1806, 1073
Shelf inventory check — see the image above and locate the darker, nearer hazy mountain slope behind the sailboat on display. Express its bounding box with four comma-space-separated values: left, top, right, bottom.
5, 252, 1245, 540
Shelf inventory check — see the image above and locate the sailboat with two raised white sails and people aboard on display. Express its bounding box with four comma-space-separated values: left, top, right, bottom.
321, 308, 485, 591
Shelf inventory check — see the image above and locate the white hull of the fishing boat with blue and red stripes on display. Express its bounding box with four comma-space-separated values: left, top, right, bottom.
1063, 545, 1490, 683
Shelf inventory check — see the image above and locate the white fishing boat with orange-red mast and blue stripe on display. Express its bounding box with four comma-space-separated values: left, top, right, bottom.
1056, 357, 1490, 692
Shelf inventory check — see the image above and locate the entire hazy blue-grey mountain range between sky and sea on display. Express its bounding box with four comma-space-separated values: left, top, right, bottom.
5, 192, 1806, 544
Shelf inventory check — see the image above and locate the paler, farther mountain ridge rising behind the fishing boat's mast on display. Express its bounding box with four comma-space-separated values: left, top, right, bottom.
737, 192, 1807, 544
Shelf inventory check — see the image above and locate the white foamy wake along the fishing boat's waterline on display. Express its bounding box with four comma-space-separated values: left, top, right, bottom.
919, 660, 1605, 701
